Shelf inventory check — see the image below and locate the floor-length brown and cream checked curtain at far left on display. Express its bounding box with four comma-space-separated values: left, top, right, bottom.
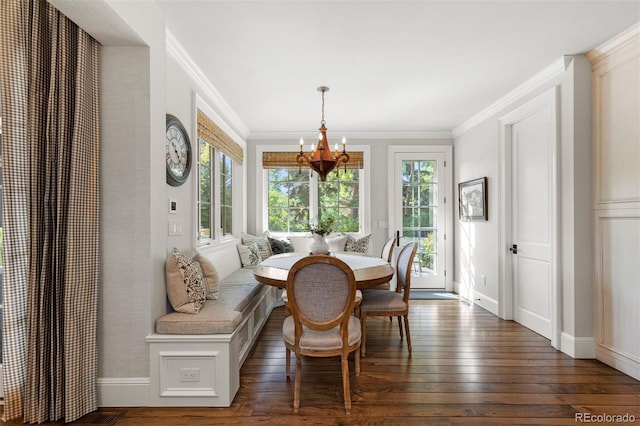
0, 0, 100, 423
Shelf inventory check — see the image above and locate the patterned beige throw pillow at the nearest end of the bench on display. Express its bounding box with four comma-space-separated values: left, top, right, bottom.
165, 248, 207, 314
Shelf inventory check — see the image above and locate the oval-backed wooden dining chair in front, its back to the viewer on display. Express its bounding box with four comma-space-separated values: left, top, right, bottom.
282, 255, 361, 414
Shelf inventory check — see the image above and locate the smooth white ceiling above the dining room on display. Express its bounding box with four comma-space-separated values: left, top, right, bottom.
156, 0, 640, 137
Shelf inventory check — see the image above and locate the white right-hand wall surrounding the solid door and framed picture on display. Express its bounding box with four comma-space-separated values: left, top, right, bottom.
454, 55, 593, 353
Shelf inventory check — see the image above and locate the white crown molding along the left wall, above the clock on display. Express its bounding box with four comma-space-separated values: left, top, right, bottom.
166, 29, 249, 140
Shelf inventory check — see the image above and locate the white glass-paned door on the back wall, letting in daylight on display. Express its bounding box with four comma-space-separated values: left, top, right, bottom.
389, 152, 451, 290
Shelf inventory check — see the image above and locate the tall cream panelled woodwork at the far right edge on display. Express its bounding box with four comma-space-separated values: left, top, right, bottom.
587, 24, 640, 380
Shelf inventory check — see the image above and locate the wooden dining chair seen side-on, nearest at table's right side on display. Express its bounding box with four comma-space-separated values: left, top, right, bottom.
360, 242, 418, 357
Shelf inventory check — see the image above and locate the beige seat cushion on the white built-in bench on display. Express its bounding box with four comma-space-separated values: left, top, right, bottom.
156, 268, 262, 334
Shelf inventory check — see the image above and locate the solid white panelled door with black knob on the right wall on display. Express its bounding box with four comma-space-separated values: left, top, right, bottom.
510, 109, 555, 339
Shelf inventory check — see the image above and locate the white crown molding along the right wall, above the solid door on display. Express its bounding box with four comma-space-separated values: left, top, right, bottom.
451, 55, 573, 138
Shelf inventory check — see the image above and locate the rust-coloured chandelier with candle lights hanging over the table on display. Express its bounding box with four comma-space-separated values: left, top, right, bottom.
296, 86, 349, 182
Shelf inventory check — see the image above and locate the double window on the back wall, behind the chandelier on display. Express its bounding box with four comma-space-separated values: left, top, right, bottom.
265, 167, 363, 233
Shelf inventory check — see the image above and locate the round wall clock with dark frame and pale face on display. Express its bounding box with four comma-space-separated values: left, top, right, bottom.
167, 114, 191, 186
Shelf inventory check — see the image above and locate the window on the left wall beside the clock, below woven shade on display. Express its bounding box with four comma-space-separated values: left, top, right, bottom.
198, 140, 233, 243
